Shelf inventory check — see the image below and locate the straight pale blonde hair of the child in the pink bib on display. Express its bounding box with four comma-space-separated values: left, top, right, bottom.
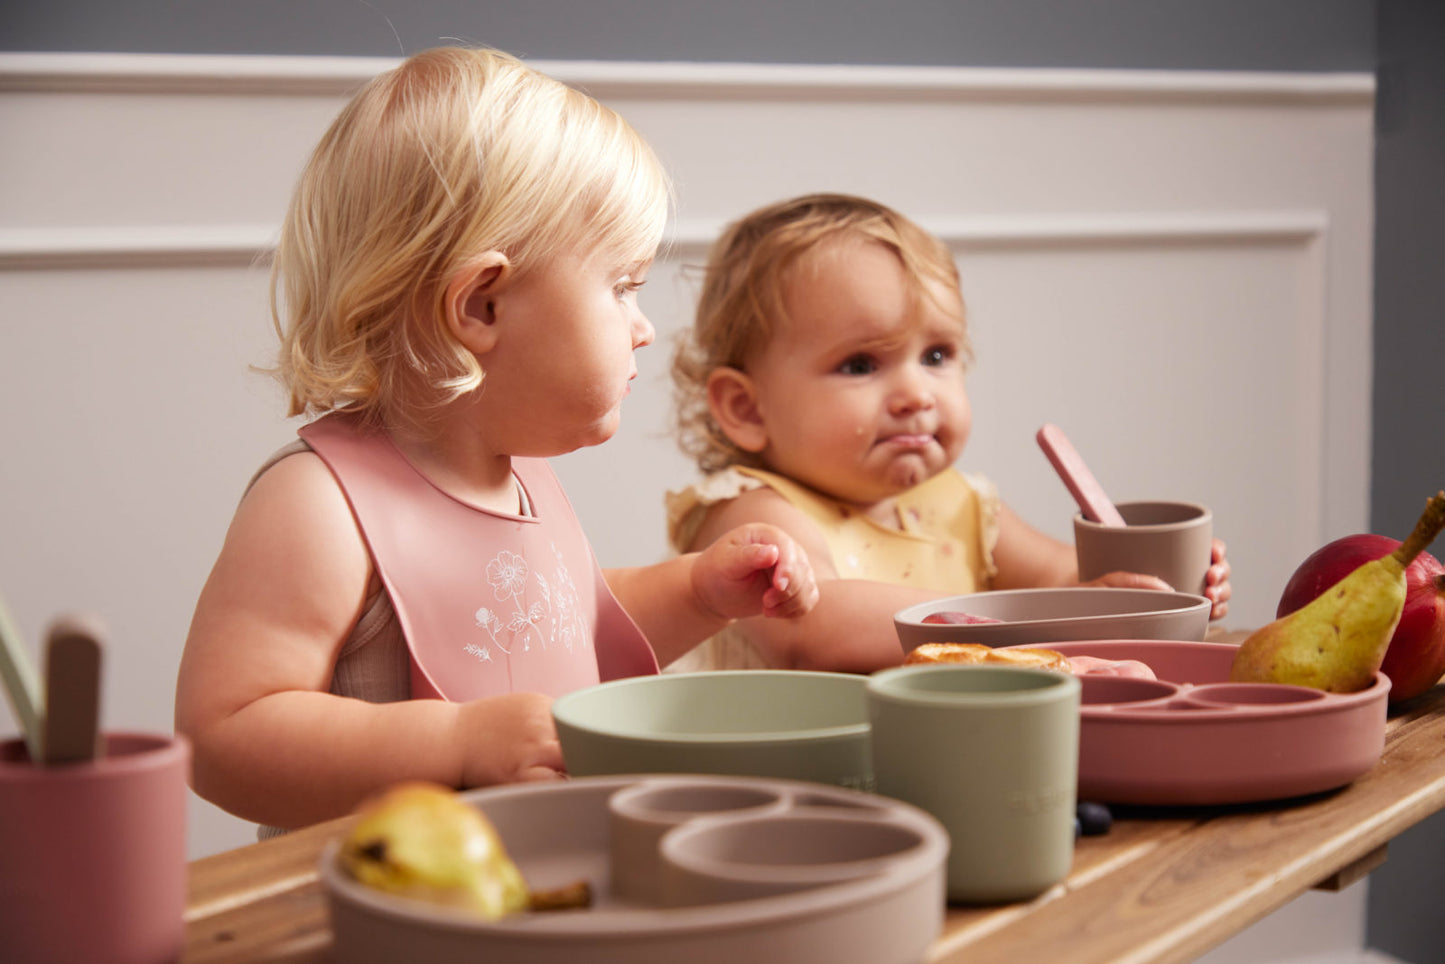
270, 48, 672, 426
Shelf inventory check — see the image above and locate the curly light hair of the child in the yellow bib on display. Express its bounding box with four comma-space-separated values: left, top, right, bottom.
672, 194, 968, 473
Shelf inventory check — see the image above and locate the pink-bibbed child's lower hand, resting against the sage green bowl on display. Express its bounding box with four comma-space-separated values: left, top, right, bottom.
454, 692, 566, 789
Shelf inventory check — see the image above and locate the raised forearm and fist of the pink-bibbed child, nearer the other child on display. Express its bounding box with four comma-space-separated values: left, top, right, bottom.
605, 523, 818, 665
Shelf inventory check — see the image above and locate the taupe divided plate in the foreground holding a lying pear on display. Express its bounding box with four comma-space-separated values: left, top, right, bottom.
321, 775, 948, 964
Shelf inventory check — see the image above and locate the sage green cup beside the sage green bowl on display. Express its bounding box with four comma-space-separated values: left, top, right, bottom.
867, 663, 1079, 903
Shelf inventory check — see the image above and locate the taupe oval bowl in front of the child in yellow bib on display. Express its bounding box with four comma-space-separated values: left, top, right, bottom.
893, 585, 1211, 652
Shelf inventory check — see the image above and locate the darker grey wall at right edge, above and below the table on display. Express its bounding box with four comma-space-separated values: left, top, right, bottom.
1366, 0, 1445, 964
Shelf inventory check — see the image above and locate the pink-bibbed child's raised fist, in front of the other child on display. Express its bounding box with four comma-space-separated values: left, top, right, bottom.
692, 523, 818, 619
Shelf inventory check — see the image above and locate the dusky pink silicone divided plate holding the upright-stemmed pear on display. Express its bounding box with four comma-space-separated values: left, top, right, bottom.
1005, 639, 1390, 805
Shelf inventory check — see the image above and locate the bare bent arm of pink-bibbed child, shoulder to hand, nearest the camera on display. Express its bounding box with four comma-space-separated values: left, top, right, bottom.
176, 454, 562, 827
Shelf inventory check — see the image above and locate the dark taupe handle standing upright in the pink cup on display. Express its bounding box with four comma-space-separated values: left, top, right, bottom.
45, 617, 101, 765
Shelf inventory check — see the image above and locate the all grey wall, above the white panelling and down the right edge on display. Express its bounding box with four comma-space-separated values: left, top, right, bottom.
0, 0, 1445, 964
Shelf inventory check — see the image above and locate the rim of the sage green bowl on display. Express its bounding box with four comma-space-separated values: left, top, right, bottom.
552, 669, 871, 746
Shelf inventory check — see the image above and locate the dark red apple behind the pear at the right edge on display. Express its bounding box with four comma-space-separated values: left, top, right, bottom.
1274, 533, 1445, 704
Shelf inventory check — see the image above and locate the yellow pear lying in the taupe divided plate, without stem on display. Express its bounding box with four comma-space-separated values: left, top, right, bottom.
341, 782, 530, 921
